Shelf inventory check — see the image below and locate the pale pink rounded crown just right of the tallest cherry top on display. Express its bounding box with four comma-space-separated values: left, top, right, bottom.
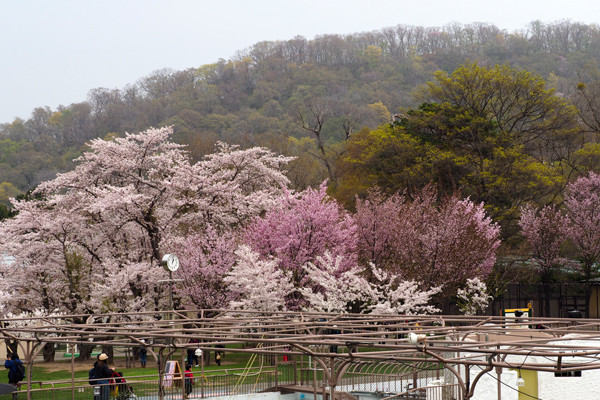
171, 143, 293, 237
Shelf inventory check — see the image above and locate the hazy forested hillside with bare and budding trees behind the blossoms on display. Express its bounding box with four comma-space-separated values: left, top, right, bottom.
0, 21, 600, 214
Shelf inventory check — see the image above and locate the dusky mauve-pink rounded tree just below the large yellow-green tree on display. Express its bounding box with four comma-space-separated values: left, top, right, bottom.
396, 188, 500, 291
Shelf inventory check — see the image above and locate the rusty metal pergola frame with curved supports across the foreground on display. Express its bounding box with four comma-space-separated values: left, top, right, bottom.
0, 310, 600, 400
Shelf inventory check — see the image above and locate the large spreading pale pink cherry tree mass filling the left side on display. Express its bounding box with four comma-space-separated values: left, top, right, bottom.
0, 128, 289, 313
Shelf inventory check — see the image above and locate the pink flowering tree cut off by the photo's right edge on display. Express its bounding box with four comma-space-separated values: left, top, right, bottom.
565, 172, 600, 281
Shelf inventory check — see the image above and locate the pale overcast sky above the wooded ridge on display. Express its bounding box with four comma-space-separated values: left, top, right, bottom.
0, 0, 600, 123
